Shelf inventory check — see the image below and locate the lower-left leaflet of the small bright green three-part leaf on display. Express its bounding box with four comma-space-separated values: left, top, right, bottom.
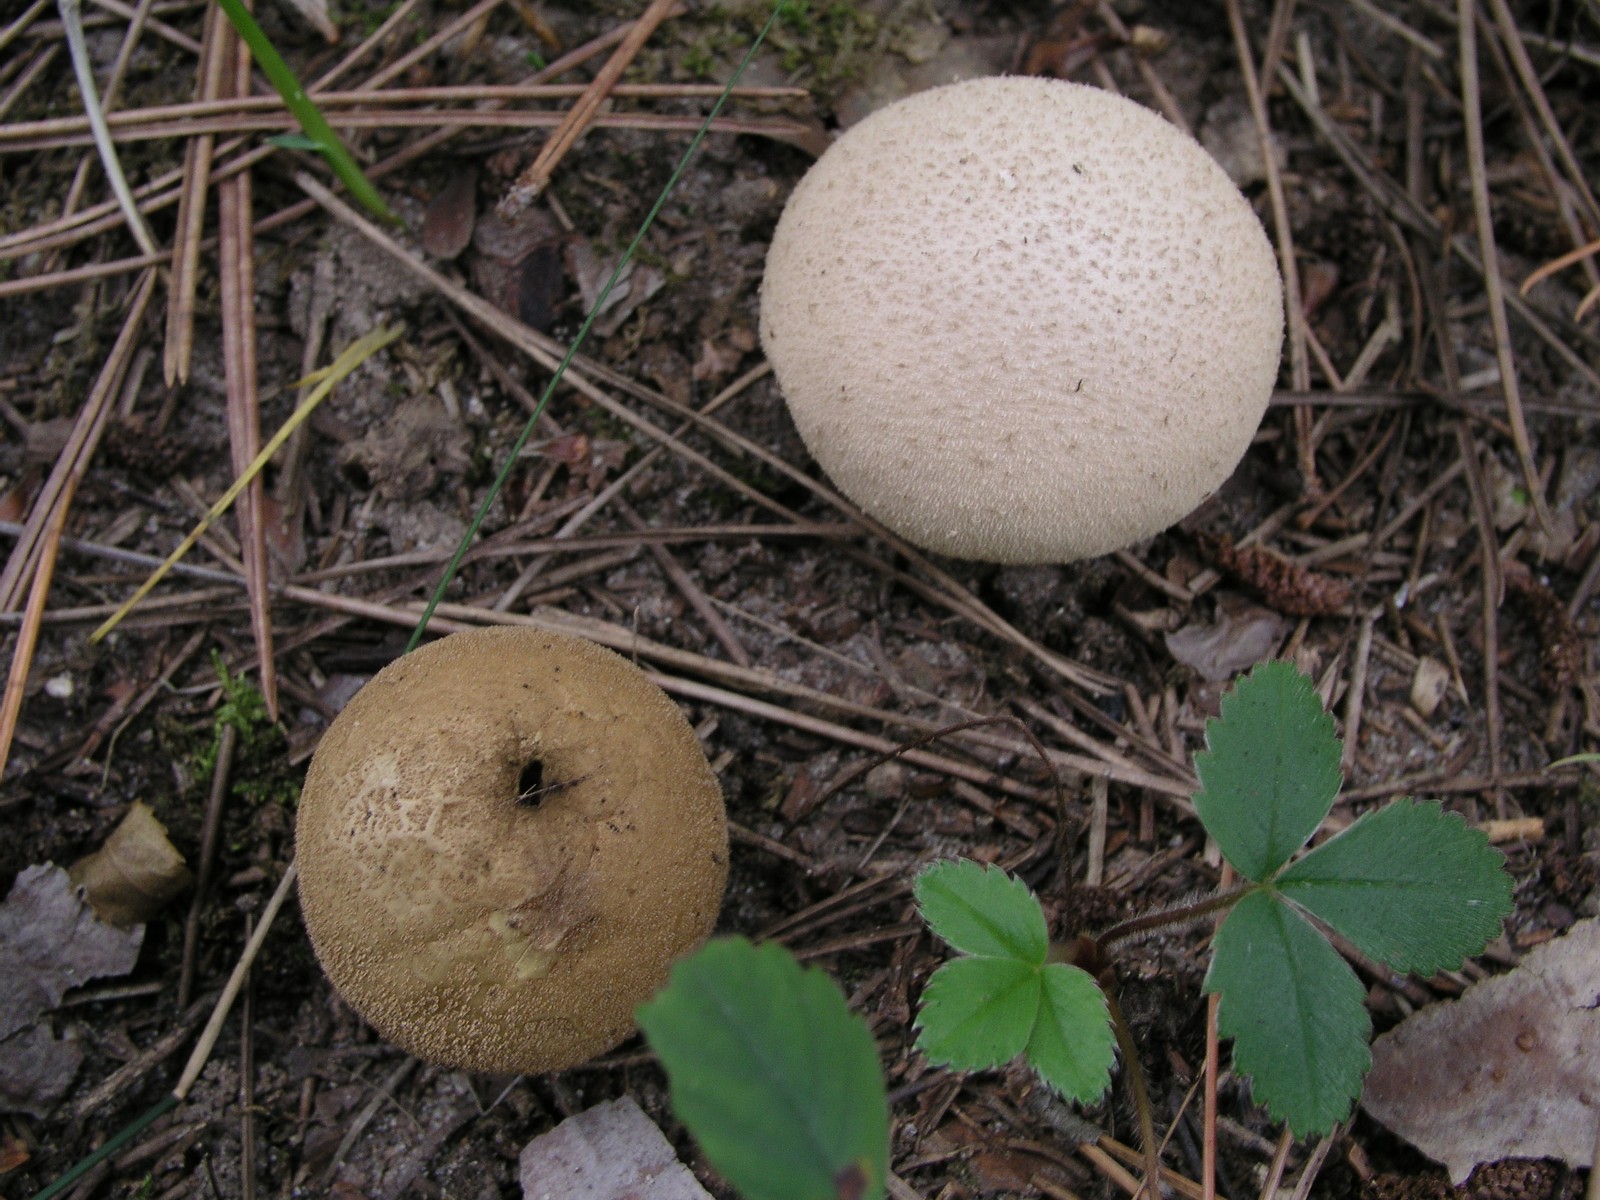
917, 958, 1043, 1070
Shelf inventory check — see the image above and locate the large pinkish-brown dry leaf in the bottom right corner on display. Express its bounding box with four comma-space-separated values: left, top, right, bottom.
1362, 920, 1600, 1184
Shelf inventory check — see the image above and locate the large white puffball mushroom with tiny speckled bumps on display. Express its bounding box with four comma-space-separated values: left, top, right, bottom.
762, 77, 1283, 563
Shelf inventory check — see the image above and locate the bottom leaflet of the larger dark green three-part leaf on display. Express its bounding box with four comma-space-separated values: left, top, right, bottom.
1205, 890, 1373, 1138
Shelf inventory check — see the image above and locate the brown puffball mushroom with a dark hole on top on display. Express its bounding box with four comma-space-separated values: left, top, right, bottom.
294, 629, 728, 1074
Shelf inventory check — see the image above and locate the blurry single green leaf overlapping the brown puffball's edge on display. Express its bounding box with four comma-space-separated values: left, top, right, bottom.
638, 938, 888, 1200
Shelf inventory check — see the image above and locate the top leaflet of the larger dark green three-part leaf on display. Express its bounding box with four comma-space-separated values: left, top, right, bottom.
1195, 662, 1341, 882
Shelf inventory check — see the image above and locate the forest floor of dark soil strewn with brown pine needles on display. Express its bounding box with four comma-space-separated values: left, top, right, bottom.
0, 0, 1600, 1200
